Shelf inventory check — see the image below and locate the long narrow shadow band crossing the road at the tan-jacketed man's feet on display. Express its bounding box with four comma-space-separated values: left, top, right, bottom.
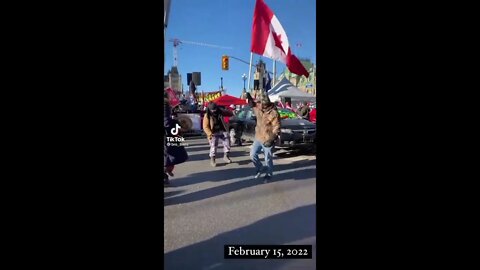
164, 168, 317, 206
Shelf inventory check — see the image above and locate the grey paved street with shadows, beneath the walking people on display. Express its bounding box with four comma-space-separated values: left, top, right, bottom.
164, 137, 316, 270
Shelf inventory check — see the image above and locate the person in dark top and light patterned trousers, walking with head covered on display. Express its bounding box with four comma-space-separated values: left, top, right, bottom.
203, 102, 233, 167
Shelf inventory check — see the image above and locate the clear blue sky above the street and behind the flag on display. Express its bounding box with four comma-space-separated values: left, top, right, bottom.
165, 0, 316, 97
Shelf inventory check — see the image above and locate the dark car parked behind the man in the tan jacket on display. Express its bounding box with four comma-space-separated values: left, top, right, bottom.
229, 106, 316, 150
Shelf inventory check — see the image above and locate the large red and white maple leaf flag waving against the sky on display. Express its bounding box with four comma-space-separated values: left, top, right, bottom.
250, 0, 309, 78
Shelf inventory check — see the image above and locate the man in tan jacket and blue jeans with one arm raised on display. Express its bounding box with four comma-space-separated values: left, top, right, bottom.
247, 91, 280, 182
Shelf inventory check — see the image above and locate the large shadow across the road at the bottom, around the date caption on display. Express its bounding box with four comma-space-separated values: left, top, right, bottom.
164, 204, 316, 270
